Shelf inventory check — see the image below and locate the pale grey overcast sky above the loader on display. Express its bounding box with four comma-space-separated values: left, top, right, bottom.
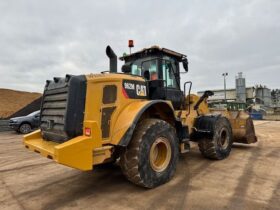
0, 0, 280, 92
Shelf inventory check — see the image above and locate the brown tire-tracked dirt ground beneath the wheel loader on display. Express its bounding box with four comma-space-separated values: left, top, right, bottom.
0, 121, 280, 210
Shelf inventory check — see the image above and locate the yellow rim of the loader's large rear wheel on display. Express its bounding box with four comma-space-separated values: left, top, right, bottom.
150, 137, 171, 172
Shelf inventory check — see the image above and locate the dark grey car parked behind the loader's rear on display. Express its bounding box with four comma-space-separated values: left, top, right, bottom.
9, 110, 40, 134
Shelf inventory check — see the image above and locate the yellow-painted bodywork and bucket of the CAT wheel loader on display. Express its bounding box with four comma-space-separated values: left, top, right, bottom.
24, 74, 255, 170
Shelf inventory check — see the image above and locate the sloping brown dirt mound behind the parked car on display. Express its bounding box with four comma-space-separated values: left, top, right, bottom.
0, 88, 42, 118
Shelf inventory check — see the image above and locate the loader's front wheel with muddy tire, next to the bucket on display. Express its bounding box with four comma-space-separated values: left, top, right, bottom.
198, 117, 233, 160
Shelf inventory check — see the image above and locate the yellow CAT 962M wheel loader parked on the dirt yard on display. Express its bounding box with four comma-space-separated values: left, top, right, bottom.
24, 46, 257, 188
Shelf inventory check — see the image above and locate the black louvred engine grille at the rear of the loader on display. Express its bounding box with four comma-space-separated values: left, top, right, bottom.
40, 75, 86, 143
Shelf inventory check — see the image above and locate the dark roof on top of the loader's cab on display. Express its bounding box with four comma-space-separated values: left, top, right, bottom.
120, 46, 187, 62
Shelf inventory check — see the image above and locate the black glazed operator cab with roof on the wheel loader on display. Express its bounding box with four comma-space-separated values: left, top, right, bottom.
120, 46, 187, 109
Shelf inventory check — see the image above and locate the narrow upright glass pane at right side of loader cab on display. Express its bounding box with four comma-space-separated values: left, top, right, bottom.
162, 60, 178, 88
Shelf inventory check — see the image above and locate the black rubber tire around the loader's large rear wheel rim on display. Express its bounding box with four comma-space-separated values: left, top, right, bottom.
120, 119, 179, 188
